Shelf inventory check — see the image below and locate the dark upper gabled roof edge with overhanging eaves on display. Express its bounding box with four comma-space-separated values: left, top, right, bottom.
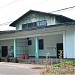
9, 10, 75, 27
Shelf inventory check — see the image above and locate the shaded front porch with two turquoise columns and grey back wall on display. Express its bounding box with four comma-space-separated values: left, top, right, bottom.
0, 33, 63, 61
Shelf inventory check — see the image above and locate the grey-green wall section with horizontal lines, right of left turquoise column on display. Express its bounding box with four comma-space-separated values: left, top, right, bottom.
16, 38, 28, 57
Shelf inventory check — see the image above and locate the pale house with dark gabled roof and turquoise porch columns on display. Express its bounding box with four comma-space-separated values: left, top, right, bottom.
0, 10, 75, 58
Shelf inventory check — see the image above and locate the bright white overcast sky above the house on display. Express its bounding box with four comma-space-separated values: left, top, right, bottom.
0, 0, 75, 31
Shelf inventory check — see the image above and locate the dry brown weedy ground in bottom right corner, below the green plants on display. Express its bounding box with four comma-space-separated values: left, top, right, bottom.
42, 64, 75, 75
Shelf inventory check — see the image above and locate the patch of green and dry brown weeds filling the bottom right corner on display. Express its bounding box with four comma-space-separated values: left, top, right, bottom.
44, 60, 75, 75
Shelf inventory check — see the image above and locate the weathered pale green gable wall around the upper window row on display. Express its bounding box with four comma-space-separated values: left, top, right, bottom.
16, 13, 58, 30
